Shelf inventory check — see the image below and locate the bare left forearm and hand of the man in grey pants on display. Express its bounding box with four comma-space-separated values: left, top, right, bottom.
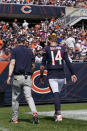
7, 59, 15, 84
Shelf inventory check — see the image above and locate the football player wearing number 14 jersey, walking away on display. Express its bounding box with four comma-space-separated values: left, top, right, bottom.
40, 33, 77, 122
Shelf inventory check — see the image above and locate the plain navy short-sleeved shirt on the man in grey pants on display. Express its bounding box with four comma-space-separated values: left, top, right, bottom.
11, 45, 35, 74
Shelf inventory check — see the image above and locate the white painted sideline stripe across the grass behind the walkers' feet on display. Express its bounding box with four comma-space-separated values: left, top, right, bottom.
25, 110, 87, 121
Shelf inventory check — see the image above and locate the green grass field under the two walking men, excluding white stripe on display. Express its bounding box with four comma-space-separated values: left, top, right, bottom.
0, 104, 87, 131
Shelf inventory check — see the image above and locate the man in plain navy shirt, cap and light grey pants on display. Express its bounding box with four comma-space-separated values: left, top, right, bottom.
7, 36, 38, 124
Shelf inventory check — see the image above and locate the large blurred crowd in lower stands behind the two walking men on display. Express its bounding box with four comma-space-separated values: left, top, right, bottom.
0, 18, 87, 63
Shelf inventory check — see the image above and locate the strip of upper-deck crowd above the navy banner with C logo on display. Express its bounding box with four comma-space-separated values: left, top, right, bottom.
0, 0, 87, 8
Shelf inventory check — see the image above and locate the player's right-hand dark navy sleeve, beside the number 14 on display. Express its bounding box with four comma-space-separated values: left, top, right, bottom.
64, 48, 75, 75
